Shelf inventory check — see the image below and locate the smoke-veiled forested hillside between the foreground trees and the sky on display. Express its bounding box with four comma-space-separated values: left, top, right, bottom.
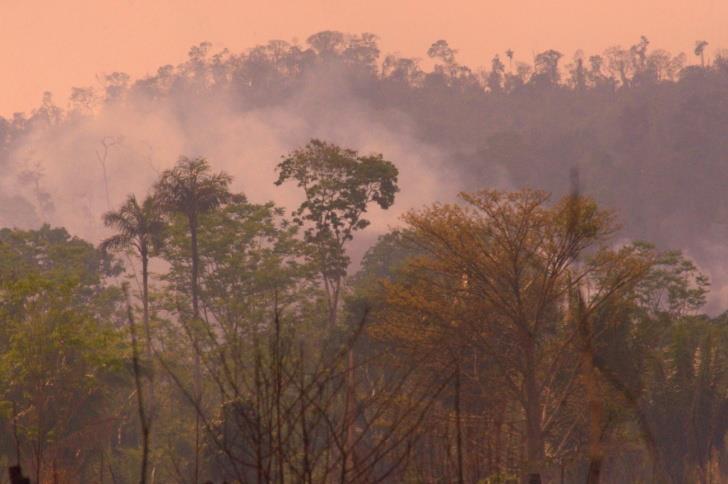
0, 32, 728, 308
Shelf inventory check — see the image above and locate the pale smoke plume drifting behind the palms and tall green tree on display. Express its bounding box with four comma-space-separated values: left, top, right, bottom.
0, 62, 456, 253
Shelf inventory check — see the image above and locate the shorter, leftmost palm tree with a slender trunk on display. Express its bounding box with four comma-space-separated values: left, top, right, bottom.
101, 195, 164, 483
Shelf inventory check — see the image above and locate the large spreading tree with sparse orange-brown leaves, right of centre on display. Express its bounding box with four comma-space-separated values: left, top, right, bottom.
388, 190, 649, 481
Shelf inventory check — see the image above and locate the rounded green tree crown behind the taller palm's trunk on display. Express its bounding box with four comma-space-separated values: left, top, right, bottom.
163, 195, 312, 320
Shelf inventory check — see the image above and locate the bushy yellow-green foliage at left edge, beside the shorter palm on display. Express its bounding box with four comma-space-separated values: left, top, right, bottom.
0, 226, 128, 480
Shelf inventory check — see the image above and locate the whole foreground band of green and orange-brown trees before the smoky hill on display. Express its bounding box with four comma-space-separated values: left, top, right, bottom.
0, 140, 728, 483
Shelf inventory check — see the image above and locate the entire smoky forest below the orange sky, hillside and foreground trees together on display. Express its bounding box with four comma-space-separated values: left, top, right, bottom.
0, 31, 728, 484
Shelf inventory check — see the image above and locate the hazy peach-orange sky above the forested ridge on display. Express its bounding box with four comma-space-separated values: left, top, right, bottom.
0, 0, 728, 115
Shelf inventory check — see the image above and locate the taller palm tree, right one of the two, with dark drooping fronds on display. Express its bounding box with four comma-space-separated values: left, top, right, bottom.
155, 156, 232, 482
